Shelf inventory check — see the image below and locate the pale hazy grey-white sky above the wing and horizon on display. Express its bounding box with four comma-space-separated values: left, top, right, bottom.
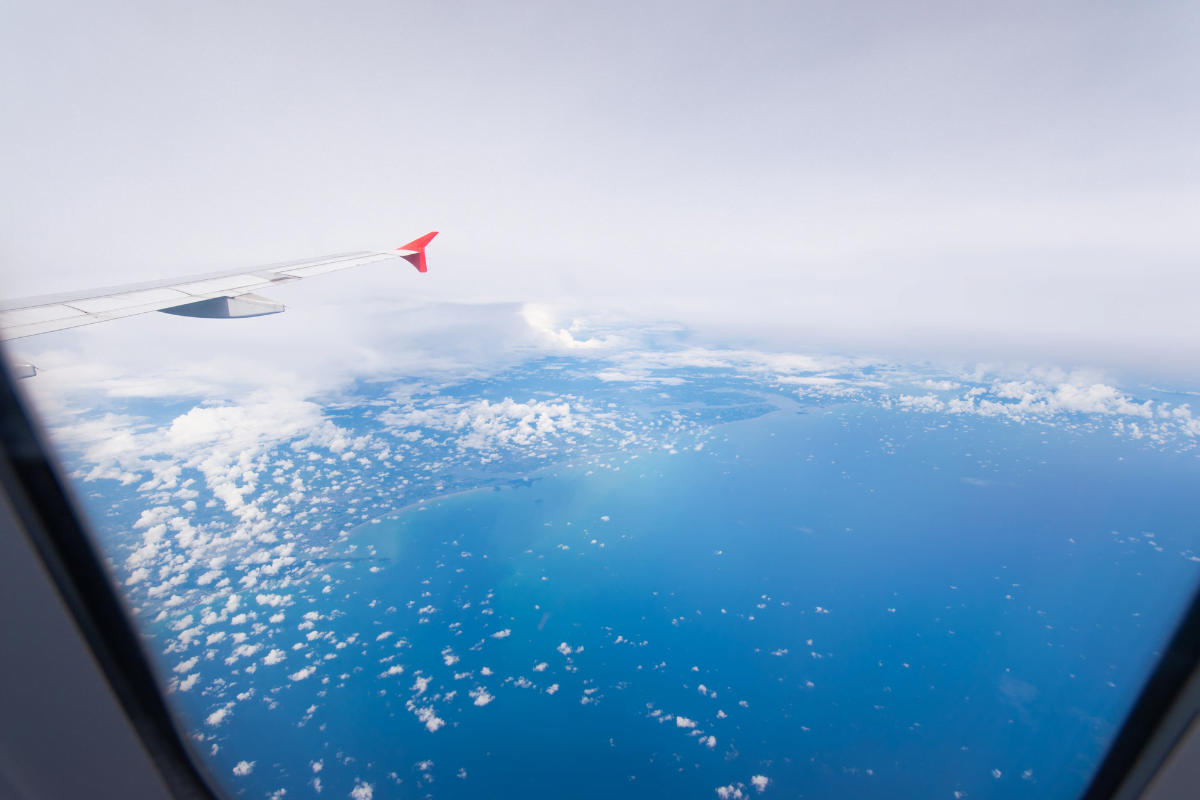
0, 0, 1200, 372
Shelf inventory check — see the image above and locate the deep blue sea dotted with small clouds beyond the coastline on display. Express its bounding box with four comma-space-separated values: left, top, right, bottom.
166, 405, 1200, 798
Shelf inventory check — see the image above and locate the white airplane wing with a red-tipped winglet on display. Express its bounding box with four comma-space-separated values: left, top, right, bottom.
0, 230, 438, 339
